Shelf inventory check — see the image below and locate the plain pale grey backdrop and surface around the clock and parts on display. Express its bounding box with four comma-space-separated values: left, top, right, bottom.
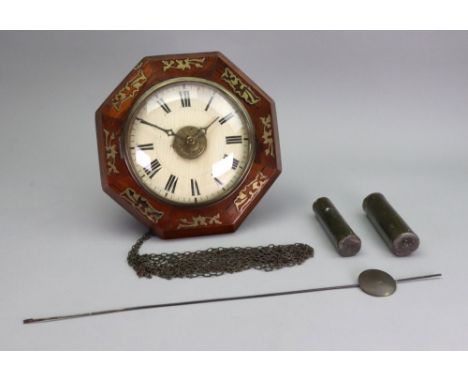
0, 32, 468, 349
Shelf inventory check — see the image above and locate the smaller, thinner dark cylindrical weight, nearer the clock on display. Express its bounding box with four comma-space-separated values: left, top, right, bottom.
312, 197, 361, 257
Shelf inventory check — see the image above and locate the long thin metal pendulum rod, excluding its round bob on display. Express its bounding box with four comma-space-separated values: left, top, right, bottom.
23, 273, 442, 324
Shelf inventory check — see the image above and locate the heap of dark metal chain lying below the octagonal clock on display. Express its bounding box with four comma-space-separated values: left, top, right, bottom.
127, 231, 314, 280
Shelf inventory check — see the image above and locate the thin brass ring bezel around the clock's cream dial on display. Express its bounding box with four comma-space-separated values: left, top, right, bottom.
120, 76, 256, 208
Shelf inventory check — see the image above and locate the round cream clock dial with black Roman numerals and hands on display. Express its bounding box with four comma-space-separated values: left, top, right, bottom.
124, 78, 255, 205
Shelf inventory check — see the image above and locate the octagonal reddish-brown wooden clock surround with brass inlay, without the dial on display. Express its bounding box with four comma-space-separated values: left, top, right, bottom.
96, 52, 281, 238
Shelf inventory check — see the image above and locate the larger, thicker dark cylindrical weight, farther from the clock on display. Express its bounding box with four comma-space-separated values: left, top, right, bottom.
362, 192, 419, 256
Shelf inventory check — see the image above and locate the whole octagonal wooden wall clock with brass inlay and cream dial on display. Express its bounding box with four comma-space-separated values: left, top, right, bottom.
96, 52, 281, 238
